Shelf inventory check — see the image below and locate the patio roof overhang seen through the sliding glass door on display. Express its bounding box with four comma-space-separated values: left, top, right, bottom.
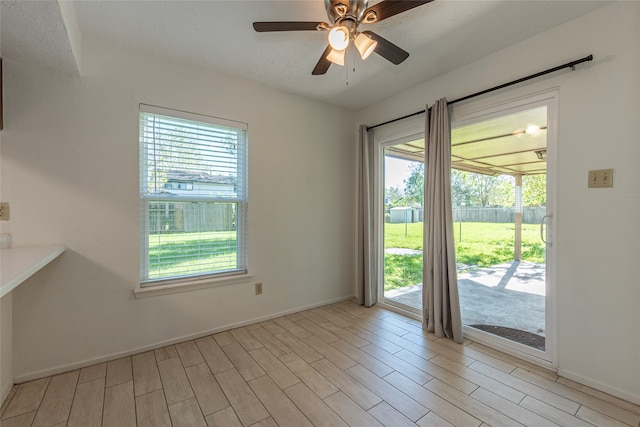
386, 106, 547, 176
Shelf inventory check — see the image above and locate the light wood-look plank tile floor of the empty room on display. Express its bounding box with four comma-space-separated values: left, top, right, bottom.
0, 301, 640, 427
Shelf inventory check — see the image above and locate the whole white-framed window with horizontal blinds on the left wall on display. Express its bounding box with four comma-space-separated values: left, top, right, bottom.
140, 105, 248, 286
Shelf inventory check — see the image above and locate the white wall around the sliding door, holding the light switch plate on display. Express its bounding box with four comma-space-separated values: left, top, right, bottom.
356, 2, 640, 402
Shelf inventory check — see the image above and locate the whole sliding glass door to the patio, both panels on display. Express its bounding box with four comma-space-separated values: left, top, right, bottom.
375, 92, 557, 364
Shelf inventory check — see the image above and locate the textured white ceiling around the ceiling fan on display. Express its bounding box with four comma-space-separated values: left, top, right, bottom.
1, 0, 606, 109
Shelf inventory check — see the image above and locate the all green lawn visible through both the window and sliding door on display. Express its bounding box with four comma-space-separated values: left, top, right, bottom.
149, 222, 544, 290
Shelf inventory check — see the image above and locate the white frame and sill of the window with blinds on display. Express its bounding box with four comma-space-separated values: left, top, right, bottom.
139, 104, 251, 290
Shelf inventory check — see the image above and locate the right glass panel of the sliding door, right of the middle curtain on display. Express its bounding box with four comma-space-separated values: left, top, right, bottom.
452, 105, 549, 352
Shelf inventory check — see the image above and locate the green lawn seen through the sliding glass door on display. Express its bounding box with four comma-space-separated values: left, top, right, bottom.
384, 222, 544, 290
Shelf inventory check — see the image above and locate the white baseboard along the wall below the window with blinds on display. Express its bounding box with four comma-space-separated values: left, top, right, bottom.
13, 295, 355, 384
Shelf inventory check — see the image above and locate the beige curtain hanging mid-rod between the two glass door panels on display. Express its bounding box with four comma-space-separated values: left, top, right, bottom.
422, 98, 462, 343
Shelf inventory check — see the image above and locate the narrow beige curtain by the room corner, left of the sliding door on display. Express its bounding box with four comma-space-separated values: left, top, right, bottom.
357, 126, 378, 307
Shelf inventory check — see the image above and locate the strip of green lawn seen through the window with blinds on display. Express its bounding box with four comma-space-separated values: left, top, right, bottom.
149, 231, 236, 279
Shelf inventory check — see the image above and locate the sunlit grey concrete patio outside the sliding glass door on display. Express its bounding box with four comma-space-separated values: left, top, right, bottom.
385, 261, 545, 336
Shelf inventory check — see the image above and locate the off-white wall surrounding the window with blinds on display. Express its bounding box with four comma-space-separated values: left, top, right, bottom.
1, 39, 355, 381
